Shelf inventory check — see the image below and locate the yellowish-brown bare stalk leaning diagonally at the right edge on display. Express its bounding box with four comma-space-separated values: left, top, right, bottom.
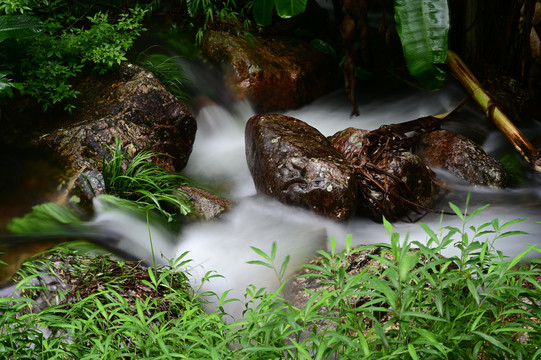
447, 50, 541, 171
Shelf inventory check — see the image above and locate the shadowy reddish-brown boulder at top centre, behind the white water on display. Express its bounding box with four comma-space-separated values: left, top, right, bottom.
202, 30, 332, 112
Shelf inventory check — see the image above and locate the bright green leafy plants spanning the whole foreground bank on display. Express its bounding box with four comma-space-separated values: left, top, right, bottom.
0, 198, 541, 359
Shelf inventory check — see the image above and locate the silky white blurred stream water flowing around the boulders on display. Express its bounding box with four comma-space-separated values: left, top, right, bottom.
95, 79, 541, 317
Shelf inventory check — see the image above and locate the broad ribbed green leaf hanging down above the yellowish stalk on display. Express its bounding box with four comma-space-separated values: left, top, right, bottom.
394, 0, 449, 90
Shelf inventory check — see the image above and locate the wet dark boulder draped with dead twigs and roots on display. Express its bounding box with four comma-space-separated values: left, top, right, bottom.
330, 128, 438, 221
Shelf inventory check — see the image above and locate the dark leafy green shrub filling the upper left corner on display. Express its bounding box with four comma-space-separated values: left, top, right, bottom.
0, 0, 151, 111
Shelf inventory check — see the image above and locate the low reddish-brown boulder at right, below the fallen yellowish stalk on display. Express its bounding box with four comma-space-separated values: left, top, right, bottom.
415, 130, 508, 187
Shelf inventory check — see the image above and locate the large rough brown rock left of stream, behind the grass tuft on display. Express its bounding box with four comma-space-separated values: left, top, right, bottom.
36, 63, 197, 212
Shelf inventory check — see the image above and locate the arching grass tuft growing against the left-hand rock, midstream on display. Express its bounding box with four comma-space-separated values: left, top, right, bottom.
102, 137, 191, 222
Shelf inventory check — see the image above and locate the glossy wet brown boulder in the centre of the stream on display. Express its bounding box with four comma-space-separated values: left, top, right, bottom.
246, 114, 357, 220
